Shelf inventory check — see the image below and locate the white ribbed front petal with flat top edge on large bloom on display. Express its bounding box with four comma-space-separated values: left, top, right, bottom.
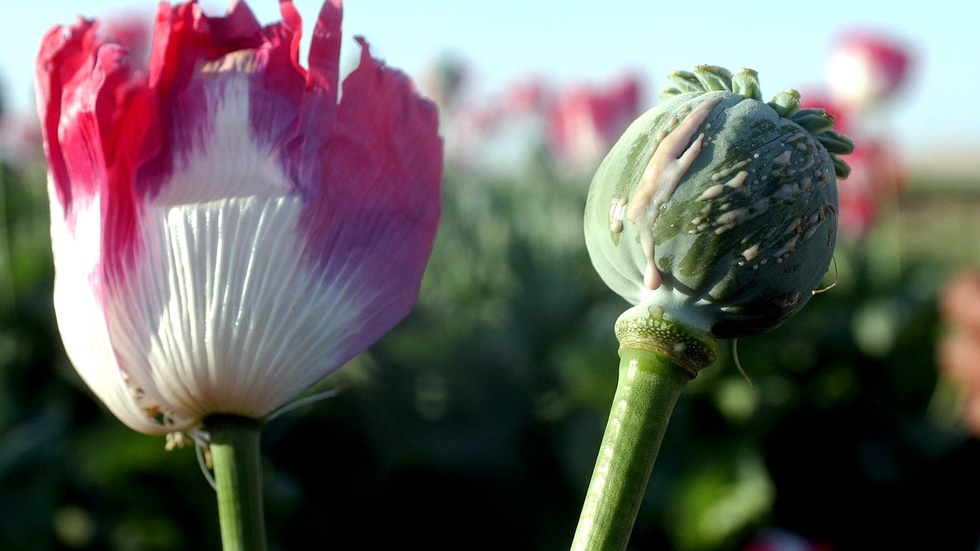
107, 196, 368, 419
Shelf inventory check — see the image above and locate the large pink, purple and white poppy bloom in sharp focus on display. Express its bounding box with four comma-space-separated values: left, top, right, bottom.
36, 0, 442, 434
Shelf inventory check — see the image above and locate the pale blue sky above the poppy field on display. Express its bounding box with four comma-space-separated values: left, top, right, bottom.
0, 0, 980, 170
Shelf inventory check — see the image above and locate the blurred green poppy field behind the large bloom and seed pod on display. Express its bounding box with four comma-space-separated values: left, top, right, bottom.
0, 29, 980, 551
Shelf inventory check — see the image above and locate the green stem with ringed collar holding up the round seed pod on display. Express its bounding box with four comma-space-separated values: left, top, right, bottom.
572, 311, 715, 551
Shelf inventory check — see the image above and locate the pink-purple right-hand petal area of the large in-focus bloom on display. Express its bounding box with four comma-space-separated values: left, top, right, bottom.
301, 40, 442, 366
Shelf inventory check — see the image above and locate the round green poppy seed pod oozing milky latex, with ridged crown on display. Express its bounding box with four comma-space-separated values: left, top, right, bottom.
585, 66, 854, 338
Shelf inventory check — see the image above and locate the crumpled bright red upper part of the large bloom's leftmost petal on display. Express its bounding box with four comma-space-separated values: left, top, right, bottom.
37, 17, 163, 287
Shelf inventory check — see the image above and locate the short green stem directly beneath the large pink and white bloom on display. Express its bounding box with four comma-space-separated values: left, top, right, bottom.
204, 415, 266, 551
